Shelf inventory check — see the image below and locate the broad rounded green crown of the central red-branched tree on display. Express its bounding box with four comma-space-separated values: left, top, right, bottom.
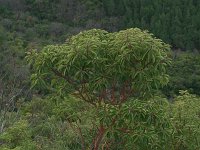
28, 28, 170, 104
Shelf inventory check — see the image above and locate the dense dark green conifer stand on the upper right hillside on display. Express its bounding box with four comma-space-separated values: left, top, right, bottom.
103, 0, 200, 49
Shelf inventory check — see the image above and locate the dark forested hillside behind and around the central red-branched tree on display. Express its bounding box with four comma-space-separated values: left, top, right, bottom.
0, 0, 200, 149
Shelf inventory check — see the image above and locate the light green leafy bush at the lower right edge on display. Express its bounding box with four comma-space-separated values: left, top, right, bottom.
171, 91, 200, 150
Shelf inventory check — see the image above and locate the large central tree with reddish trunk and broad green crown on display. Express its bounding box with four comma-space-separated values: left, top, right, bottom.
27, 28, 170, 150
